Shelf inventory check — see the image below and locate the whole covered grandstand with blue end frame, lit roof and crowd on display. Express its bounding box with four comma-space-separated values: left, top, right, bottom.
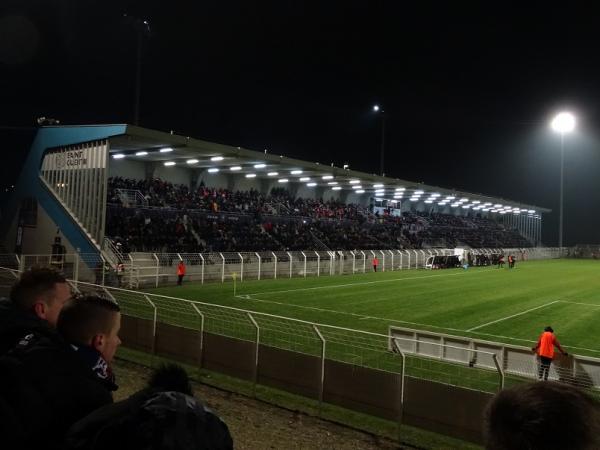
0, 125, 549, 261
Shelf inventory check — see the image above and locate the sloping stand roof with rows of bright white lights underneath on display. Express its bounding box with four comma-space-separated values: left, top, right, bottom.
105, 125, 551, 215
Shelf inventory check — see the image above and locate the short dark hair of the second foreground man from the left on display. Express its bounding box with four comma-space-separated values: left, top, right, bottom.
56, 295, 120, 345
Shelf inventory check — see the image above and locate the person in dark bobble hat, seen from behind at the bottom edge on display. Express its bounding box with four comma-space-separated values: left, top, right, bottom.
66, 365, 233, 450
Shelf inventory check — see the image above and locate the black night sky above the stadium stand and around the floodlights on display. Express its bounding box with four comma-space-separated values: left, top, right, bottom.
0, 0, 600, 244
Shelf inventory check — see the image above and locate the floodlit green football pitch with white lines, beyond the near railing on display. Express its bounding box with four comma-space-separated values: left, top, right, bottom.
149, 260, 600, 357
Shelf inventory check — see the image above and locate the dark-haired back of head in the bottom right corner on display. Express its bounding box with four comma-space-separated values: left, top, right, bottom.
485, 381, 600, 450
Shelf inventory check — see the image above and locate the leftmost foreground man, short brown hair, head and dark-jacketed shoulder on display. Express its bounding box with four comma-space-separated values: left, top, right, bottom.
0, 267, 71, 356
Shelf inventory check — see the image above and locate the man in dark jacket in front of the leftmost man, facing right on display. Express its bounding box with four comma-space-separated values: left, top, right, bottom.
0, 295, 120, 450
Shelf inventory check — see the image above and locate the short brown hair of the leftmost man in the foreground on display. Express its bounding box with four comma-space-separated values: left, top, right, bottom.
10, 267, 67, 311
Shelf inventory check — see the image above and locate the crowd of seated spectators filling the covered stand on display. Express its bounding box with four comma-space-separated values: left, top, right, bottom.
106, 177, 531, 253
